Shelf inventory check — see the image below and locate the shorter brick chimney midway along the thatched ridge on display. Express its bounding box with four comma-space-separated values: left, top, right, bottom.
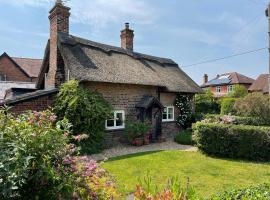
121, 23, 134, 51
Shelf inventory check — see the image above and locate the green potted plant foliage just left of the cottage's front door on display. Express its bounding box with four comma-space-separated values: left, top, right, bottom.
124, 122, 151, 143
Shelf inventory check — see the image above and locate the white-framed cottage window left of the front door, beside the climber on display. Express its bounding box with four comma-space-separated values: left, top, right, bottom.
106, 110, 125, 130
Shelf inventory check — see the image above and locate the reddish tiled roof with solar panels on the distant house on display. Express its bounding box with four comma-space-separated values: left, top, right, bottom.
201, 72, 254, 88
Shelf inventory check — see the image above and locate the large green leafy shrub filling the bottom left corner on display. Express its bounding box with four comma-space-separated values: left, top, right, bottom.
0, 110, 70, 199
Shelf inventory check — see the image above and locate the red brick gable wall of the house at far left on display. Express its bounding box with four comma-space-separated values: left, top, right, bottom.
0, 57, 31, 82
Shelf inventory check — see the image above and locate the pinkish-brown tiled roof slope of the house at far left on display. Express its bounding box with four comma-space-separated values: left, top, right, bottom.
12, 57, 42, 78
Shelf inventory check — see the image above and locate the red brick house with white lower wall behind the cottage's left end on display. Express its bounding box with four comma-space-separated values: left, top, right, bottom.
0, 53, 42, 102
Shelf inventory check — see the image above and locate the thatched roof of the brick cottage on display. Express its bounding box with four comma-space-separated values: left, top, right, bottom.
58, 33, 201, 93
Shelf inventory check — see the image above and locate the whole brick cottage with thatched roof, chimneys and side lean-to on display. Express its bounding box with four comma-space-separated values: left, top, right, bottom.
1, 0, 202, 143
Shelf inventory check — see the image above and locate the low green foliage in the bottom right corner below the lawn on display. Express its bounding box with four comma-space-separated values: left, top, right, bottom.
210, 184, 270, 200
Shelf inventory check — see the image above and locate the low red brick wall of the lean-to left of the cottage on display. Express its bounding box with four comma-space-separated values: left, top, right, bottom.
9, 94, 55, 114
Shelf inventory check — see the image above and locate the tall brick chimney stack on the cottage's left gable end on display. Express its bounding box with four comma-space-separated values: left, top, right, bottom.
45, 0, 70, 88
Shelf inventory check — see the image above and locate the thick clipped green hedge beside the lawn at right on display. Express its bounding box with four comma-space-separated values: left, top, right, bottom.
193, 122, 270, 161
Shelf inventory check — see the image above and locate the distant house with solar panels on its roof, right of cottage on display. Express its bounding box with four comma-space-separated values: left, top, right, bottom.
201, 72, 254, 97
